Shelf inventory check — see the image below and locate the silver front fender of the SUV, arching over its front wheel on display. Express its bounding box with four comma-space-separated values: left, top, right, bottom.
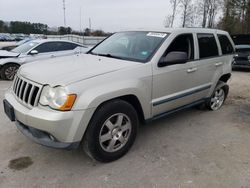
73, 79, 151, 119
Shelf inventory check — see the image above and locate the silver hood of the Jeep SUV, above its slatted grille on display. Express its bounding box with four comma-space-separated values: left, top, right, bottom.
19, 54, 141, 86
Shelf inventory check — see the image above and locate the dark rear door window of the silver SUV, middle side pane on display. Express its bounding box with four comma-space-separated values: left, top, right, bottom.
197, 33, 219, 58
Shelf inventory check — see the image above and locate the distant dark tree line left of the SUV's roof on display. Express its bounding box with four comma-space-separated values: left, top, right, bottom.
0, 20, 109, 36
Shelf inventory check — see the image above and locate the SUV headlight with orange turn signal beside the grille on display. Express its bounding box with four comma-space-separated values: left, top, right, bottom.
39, 86, 76, 111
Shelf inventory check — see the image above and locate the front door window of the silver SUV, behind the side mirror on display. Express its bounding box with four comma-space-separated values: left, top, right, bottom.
163, 34, 194, 60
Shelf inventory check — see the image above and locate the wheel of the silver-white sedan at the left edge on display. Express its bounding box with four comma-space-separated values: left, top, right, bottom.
1, 63, 20, 80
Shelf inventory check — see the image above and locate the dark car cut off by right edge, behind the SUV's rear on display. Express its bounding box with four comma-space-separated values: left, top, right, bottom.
232, 34, 250, 69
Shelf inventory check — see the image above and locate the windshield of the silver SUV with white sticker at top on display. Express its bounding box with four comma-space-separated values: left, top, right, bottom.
89, 31, 168, 62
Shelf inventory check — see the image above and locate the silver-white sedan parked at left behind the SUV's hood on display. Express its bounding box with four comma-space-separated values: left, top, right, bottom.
0, 39, 89, 80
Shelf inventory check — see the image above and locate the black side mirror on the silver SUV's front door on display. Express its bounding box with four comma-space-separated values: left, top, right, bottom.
158, 51, 188, 67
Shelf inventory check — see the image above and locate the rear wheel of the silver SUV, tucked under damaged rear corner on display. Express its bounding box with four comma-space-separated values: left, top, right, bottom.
206, 81, 229, 111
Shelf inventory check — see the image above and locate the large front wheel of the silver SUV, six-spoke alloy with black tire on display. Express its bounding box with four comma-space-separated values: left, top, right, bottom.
83, 100, 139, 162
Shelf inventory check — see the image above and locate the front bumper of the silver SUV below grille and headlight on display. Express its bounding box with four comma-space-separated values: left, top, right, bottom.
5, 91, 95, 148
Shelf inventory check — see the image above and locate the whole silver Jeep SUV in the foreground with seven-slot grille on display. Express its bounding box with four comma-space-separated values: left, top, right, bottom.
4, 28, 235, 162
